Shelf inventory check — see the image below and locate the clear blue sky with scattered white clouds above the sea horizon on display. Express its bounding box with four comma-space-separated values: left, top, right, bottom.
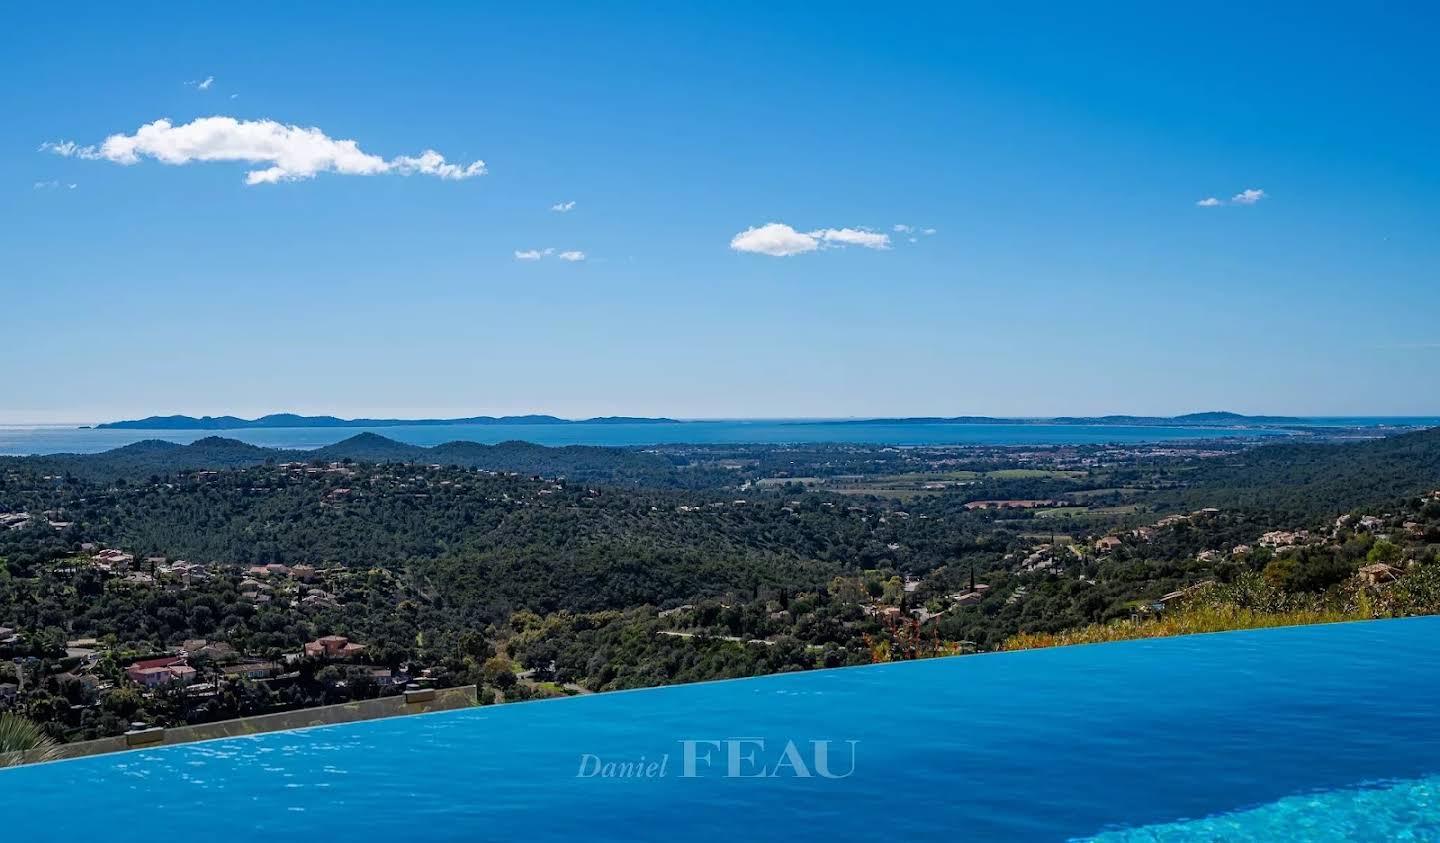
0, 3, 1440, 422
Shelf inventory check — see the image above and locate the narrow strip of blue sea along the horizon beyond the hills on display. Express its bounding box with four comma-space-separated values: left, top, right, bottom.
0, 416, 1440, 455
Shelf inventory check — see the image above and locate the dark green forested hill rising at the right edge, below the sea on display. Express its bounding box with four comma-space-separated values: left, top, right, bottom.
1182, 428, 1440, 517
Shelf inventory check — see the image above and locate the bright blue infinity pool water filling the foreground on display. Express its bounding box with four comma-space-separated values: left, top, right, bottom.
8, 618, 1440, 842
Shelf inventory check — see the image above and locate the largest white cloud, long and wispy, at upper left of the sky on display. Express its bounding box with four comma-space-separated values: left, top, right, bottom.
40, 117, 485, 184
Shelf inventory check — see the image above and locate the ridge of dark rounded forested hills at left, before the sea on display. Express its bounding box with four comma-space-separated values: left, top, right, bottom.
0, 434, 678, 486
